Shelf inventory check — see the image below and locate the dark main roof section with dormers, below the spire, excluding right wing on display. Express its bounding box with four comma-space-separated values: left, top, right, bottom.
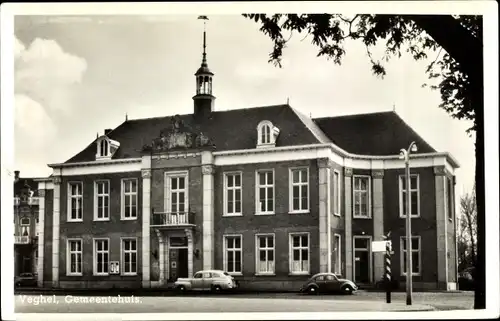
66, 105, 321, 163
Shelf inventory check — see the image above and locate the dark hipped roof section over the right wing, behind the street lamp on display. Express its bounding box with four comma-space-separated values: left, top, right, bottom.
314, 111, 436, 156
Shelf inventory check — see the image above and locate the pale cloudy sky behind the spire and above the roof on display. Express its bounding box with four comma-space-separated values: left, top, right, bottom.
10, 15, 475, 195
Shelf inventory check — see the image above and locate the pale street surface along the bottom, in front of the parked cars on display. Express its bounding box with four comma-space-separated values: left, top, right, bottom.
11, 291, 474, 313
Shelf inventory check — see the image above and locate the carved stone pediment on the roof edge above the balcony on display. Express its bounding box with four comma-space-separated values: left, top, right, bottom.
142, 115, 215, 152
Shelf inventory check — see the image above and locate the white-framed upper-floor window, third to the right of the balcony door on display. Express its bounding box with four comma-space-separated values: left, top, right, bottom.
290, 168, 309, 213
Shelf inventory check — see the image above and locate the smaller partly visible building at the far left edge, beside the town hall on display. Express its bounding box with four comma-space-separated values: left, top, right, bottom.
14, 171, 40, 276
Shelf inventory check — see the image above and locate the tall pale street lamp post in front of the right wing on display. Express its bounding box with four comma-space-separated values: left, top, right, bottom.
399, 142, 417, 305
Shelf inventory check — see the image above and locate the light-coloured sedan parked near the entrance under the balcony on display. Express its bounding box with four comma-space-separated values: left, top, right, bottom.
174, 270, 238, 293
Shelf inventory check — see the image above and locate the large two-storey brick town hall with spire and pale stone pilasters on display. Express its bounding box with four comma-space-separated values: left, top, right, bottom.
25, 24, 458, 290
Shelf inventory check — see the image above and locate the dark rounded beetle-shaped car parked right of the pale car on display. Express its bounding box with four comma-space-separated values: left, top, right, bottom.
300, 273, 358, 294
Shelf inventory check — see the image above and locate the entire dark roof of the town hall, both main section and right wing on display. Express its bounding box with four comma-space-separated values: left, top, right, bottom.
66, 105, 436, 163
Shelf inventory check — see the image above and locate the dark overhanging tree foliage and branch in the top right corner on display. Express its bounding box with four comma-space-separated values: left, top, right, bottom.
243, 14, 482, 132
